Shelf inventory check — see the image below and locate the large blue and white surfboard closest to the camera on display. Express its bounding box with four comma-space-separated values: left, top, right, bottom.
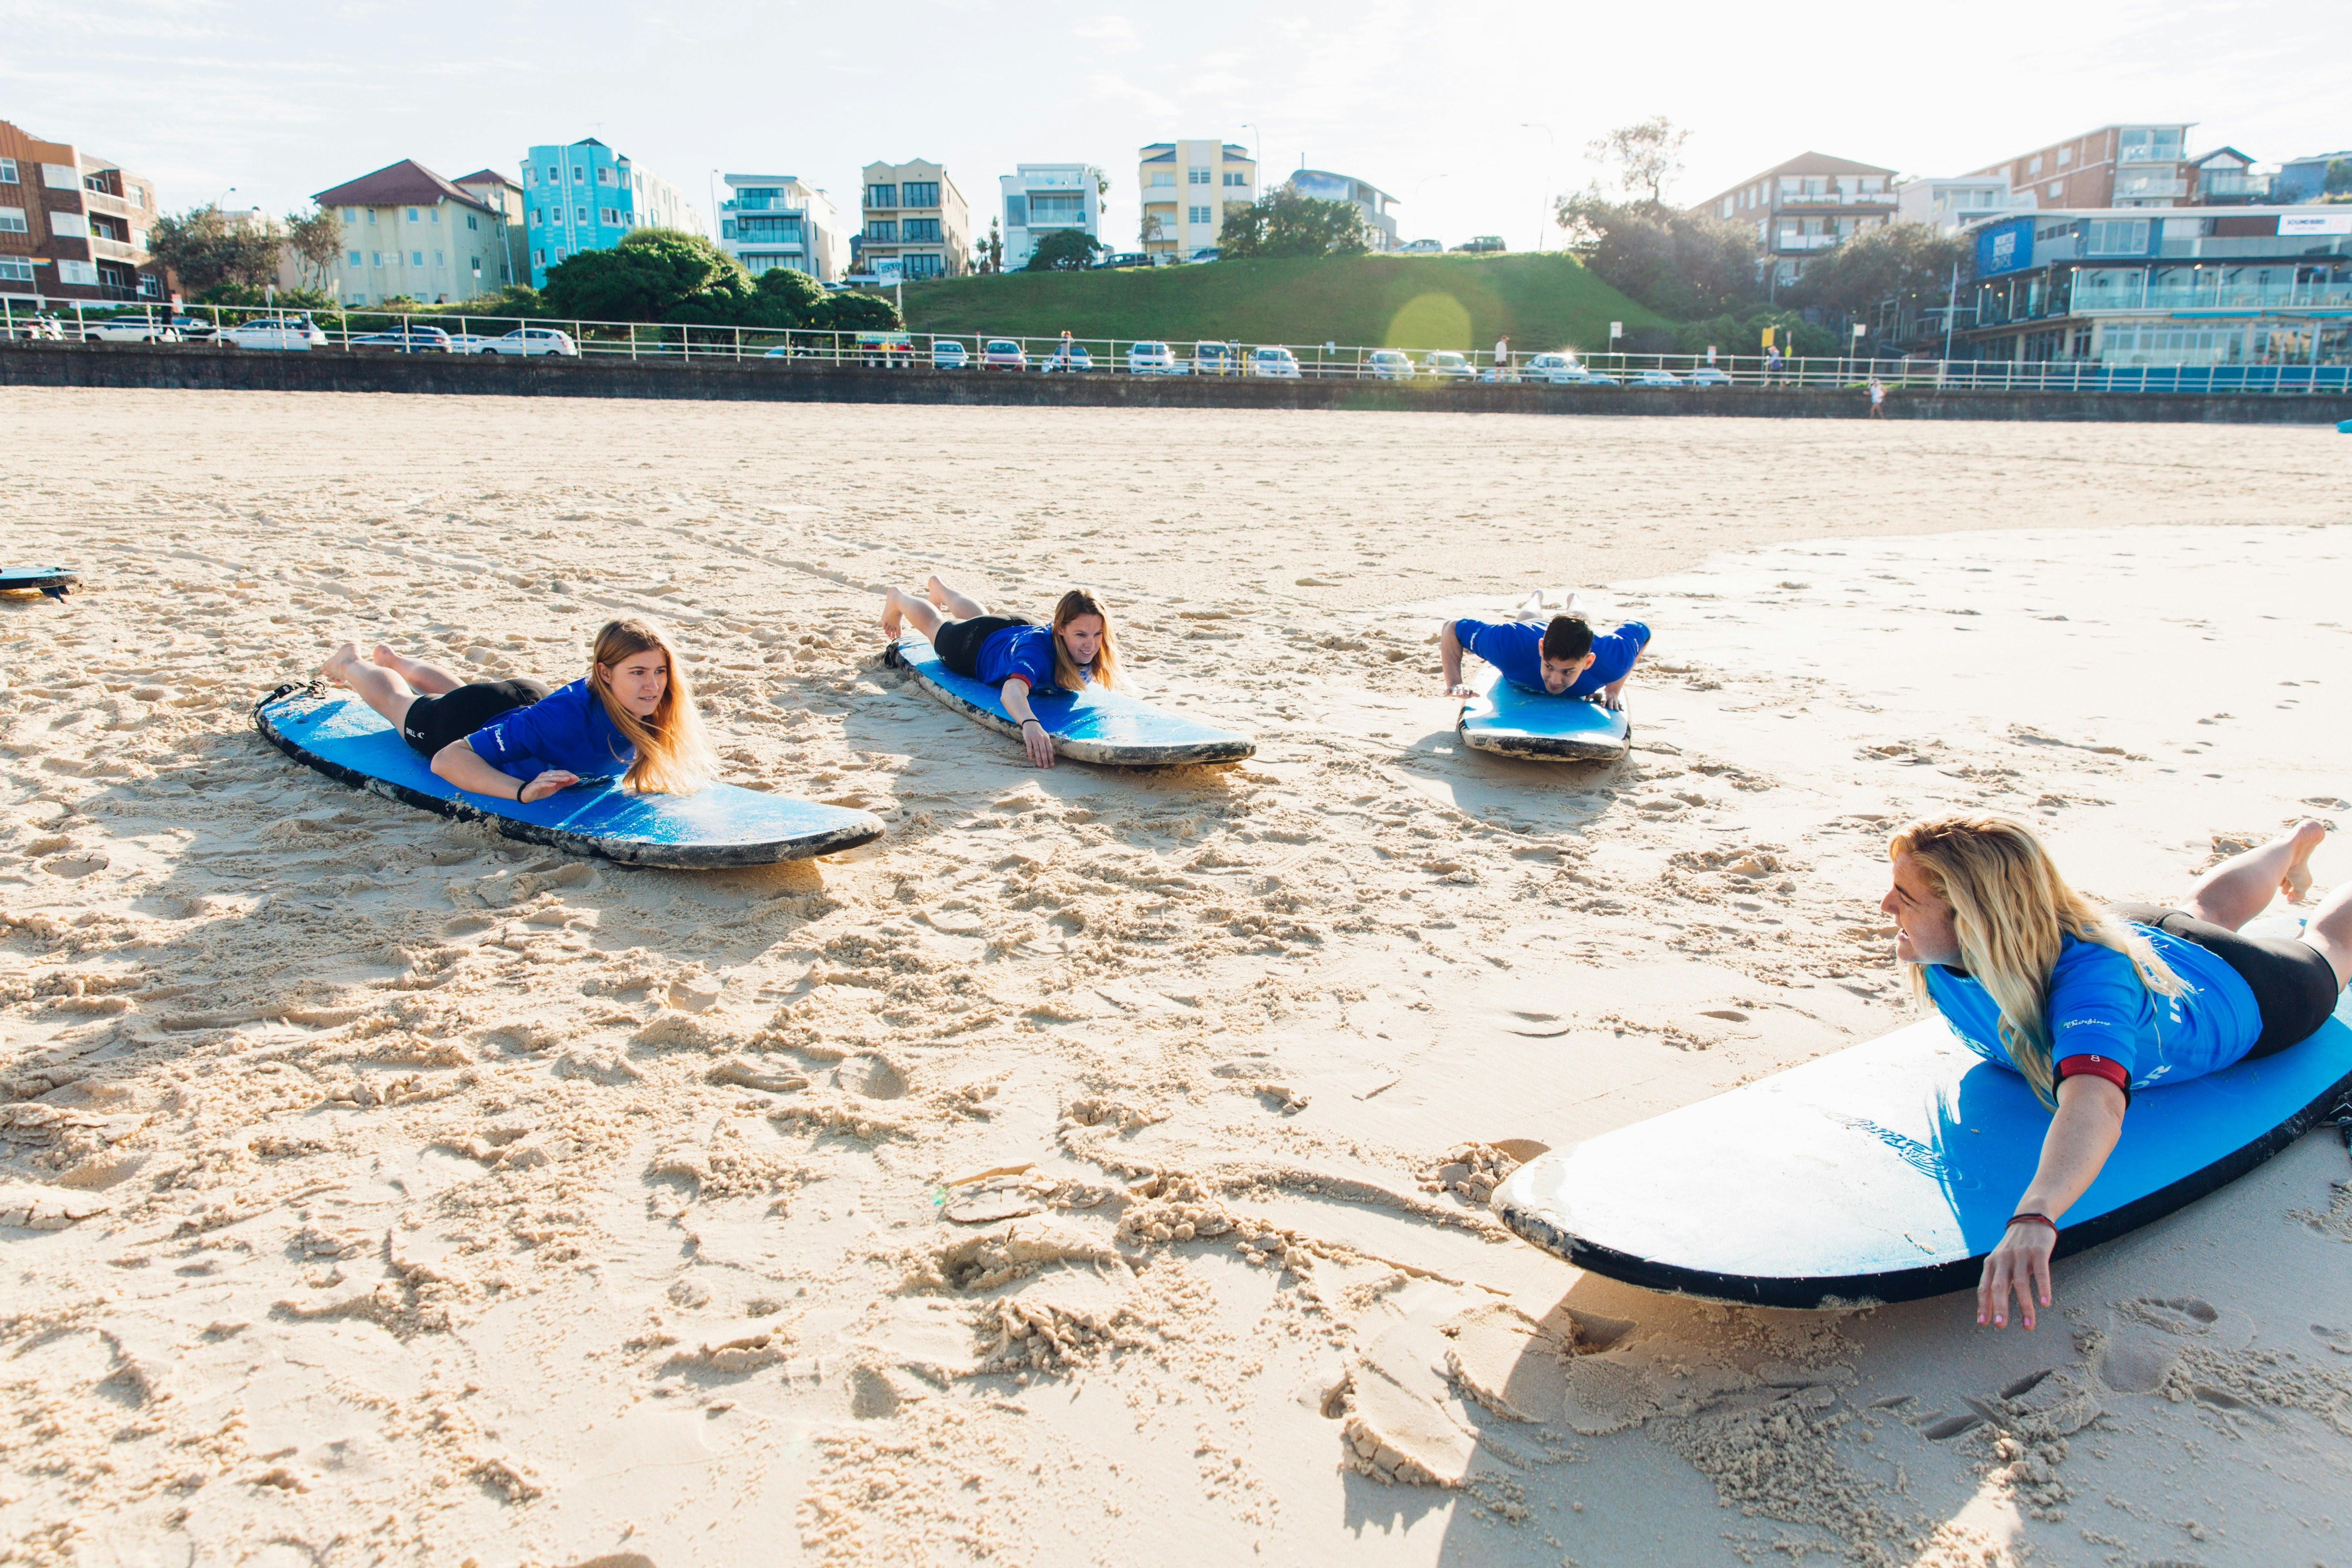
1494, 997, 2352, 1307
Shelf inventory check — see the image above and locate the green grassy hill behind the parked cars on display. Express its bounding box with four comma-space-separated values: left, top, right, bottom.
906, 256, 1668, 353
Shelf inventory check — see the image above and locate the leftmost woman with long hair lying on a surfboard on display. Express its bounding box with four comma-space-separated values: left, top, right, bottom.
318, 618, 717, 802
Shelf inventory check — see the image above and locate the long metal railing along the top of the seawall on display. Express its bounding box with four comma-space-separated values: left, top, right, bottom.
13, 294, 2352, 395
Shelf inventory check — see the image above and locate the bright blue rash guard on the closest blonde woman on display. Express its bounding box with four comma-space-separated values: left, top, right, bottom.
1926, 926, 2263, 1089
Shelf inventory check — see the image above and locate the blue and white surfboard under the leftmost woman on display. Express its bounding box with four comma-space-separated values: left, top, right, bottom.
254, 686, 882, 870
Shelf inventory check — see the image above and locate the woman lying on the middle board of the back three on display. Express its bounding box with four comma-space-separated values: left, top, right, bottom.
882, 576, 1120, 769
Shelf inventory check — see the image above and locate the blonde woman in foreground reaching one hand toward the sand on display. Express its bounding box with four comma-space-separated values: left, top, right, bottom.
1879, 816, 2352, 1328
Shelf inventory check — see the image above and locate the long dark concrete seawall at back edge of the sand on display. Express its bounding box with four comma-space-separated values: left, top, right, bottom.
0, 343, 2352, 425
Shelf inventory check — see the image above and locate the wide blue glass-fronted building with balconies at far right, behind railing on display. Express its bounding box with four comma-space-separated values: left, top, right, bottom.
1957, 207, 2352, 364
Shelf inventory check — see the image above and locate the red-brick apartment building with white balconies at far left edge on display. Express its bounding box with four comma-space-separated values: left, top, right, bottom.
0, 120, 165, 301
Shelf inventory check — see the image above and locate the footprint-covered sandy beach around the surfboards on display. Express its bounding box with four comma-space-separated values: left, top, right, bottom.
0, 390, 2352, 1568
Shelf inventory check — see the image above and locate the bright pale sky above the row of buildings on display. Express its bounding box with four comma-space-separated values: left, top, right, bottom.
0, 0, 2352, 249
